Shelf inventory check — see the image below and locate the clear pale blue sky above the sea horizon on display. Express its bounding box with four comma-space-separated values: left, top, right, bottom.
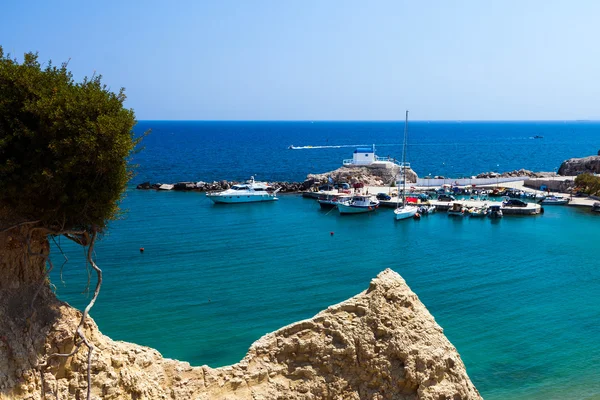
0, 0, 600, 120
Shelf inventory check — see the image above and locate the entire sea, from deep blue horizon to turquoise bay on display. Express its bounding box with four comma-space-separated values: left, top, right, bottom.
51, 121, 600, 400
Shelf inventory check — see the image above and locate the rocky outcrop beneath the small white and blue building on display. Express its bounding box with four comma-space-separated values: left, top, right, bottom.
306, 163, 418, 186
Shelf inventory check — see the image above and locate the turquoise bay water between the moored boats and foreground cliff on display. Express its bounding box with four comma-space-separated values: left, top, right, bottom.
52, 190, 600, 400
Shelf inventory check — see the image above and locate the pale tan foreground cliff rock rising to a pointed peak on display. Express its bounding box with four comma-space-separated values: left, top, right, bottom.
0, 269, 481, 400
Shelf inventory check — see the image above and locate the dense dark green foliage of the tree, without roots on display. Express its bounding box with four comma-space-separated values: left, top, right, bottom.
0, 47, 137, 230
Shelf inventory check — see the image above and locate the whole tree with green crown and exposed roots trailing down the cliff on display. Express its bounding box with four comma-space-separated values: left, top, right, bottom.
0, 47, 139, 399
